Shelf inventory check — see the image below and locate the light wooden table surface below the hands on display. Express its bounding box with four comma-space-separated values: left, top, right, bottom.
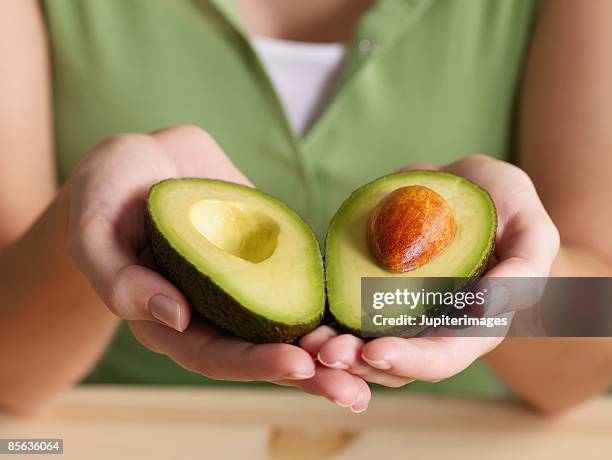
0, 386, 612, 460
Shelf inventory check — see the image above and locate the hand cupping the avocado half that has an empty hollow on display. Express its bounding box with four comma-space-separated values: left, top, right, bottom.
68, 126, 370, 412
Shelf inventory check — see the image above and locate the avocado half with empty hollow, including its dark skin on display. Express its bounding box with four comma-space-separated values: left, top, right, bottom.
146, 179, 325, 342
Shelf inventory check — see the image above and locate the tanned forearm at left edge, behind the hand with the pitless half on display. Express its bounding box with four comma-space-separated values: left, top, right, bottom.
0, 185, 117, 412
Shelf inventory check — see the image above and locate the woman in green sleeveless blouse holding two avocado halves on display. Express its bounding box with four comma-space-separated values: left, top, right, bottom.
0, 0, 612, 412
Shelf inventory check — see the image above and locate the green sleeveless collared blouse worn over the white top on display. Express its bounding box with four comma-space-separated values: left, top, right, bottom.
44, 0, 536, 395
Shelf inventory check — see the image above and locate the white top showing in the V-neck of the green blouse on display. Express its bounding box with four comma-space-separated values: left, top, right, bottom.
252, 37, 346, 137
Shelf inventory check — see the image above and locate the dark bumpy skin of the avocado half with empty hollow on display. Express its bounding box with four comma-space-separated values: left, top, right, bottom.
145, 204, 323, 343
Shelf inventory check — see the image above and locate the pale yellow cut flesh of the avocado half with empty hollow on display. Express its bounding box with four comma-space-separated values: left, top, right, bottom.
149, 179, 324, 324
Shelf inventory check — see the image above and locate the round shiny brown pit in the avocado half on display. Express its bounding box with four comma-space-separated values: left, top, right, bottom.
368, 185, 457, 273
